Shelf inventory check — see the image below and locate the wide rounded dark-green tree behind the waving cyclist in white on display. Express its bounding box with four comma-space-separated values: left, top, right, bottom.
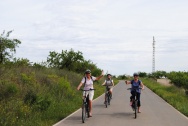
47, 49, 101, 76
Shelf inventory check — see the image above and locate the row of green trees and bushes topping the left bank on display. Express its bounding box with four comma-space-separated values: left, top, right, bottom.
0, 31, 101, 76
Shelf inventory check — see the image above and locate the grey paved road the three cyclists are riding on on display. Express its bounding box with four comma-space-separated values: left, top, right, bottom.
54, 81, 188, 126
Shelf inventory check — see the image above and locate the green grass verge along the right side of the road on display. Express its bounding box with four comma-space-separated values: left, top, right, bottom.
142, 78, 188, 117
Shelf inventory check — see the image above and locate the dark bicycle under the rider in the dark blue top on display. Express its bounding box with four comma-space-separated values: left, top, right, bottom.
127, 88, 142, 119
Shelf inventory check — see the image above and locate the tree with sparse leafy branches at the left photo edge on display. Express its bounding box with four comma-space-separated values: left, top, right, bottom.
0, 31, 21, 64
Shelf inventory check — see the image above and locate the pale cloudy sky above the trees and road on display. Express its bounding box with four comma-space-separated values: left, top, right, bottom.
0, 0, 188, 75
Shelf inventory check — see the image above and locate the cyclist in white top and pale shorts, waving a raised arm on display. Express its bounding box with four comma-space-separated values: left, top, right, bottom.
77, 69, 104, 117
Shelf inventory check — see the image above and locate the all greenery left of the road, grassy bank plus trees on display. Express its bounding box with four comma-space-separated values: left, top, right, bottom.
0, 31, 118, 126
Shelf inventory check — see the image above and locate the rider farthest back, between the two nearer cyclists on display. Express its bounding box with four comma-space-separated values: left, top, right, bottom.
102, 74, 114, 104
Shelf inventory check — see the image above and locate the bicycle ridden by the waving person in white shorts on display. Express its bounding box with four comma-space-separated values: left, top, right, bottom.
81, 89, 95, 123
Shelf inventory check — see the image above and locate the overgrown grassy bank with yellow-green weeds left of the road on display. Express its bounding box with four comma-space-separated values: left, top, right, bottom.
0, 66, 117, 126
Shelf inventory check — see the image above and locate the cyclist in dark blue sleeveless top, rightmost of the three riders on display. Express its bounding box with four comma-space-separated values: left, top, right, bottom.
125, 73, 144, 113
